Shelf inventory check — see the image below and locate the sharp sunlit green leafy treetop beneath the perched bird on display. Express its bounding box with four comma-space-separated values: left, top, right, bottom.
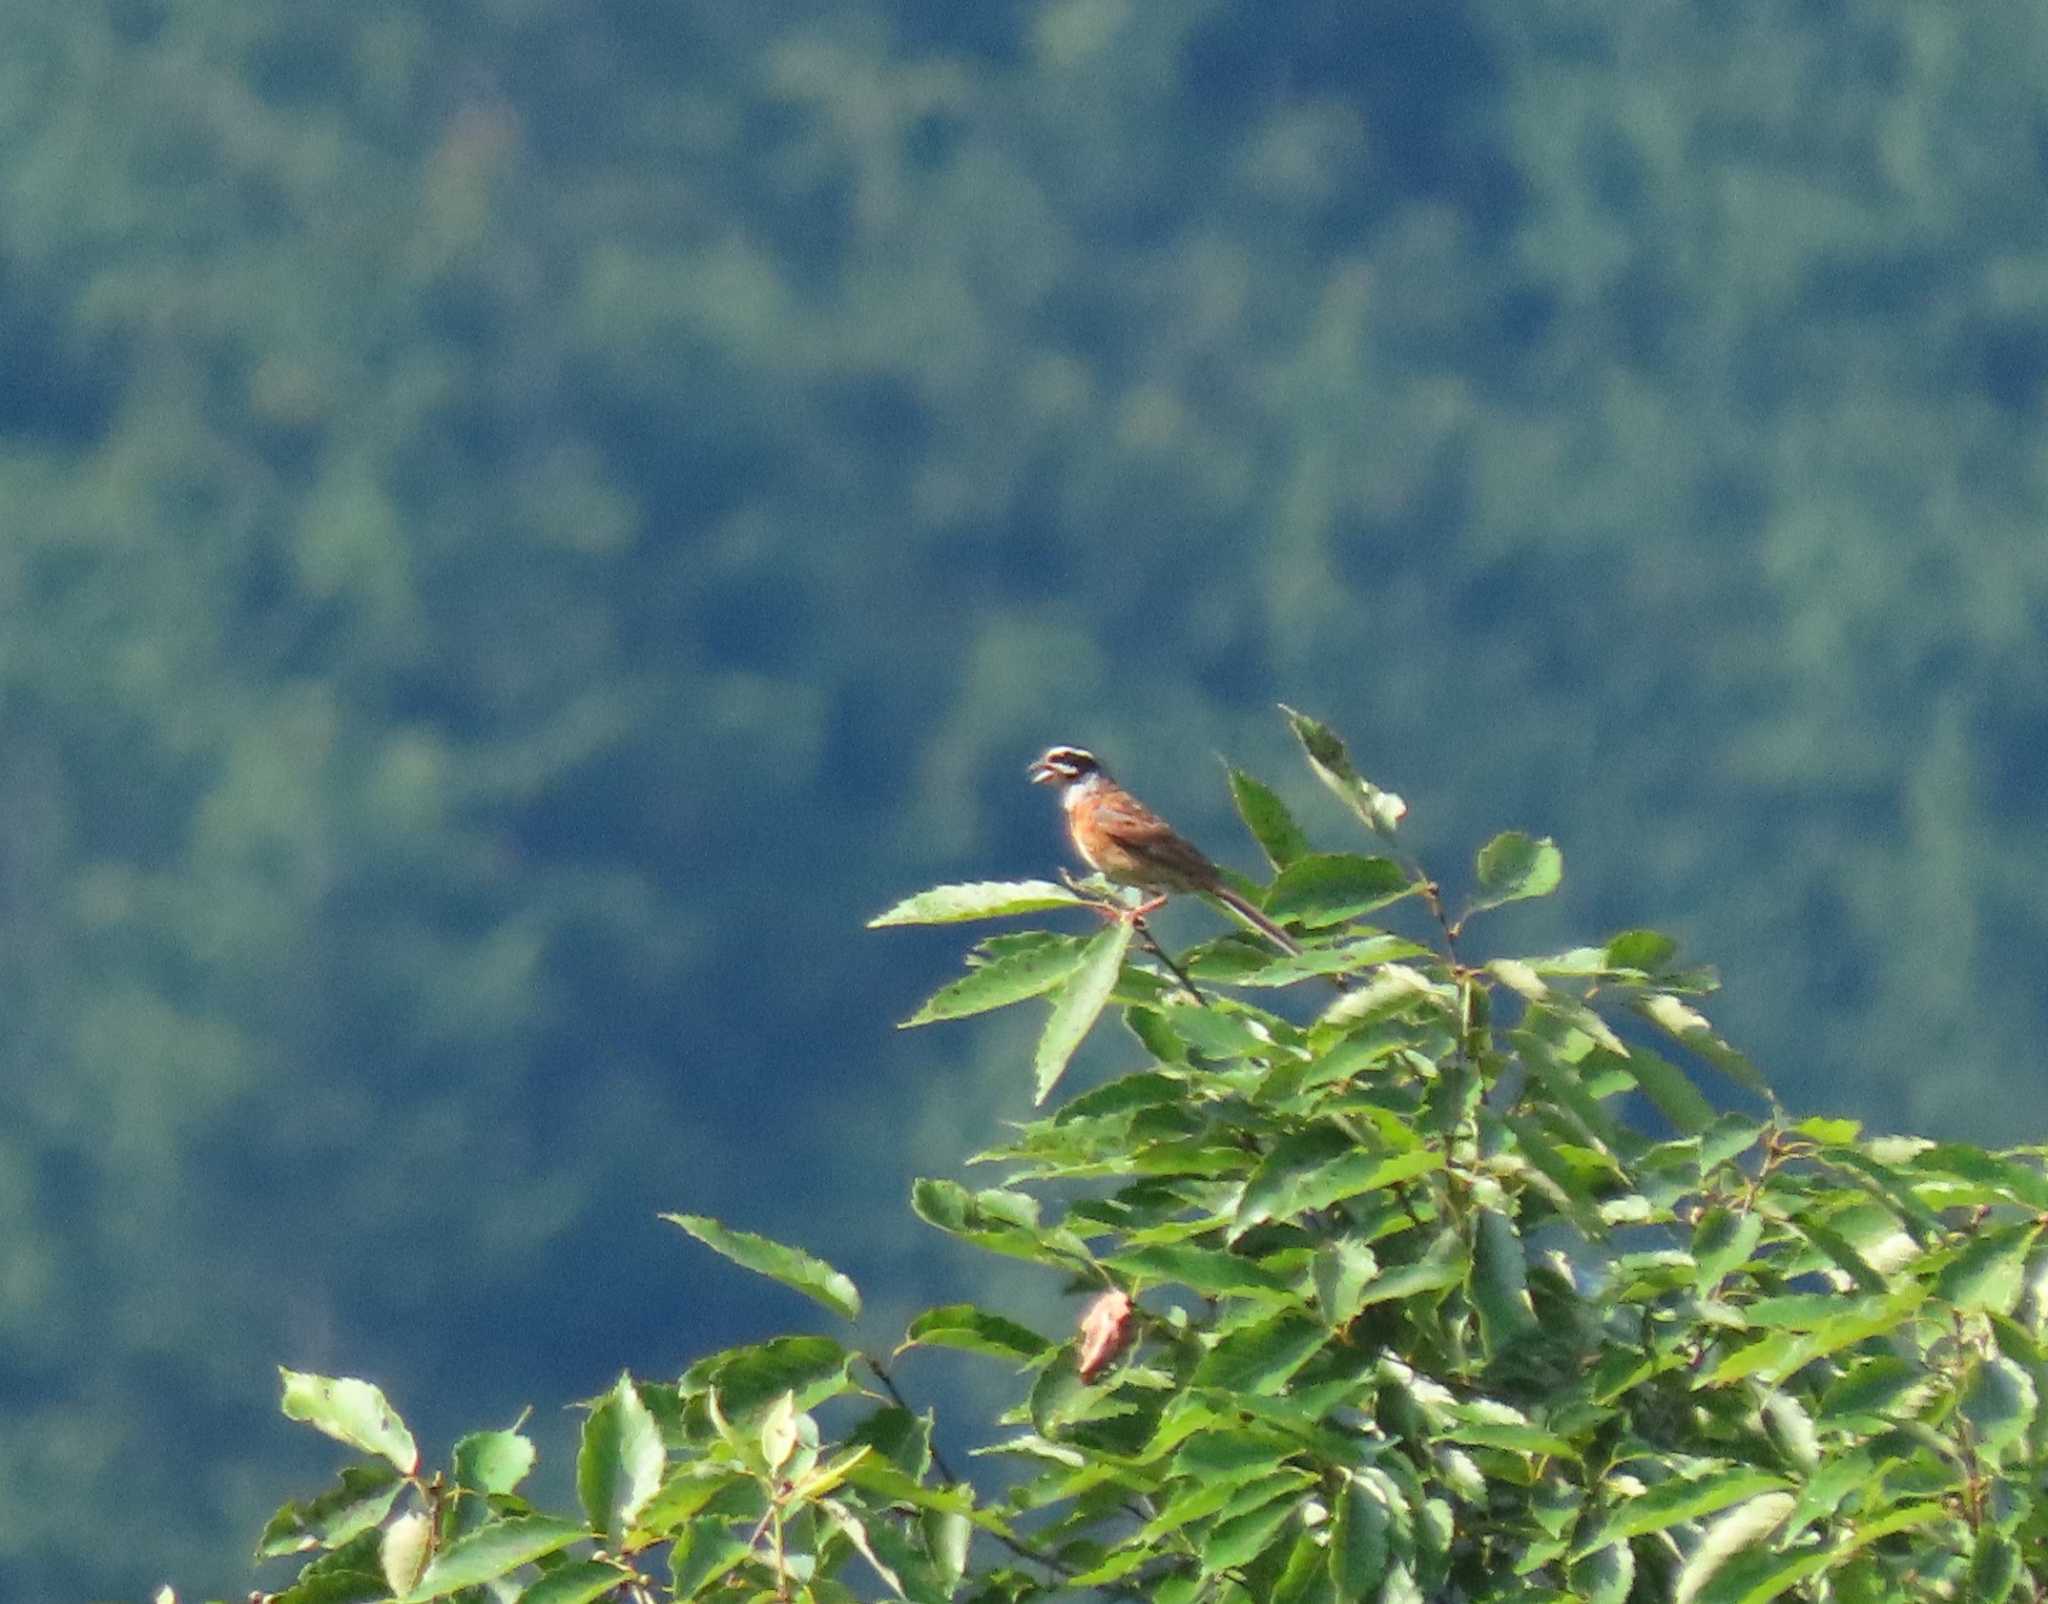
262, 729, 2048, 1604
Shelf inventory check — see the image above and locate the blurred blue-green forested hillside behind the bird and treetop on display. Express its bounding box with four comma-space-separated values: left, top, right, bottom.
0, 0, 2048, 1598
